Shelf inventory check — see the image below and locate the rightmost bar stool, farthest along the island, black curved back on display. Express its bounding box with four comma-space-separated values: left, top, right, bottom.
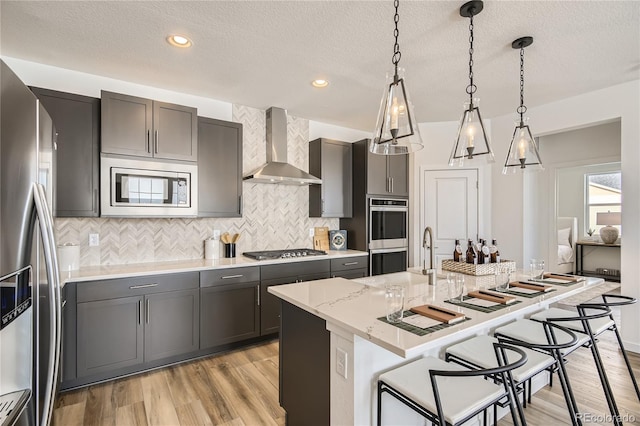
531, 294, 640, 401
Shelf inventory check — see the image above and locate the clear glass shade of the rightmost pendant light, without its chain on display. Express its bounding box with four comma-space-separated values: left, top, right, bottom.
502, 118, 544, 174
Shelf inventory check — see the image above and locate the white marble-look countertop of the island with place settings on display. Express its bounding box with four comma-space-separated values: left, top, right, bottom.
268, 272, 604, 358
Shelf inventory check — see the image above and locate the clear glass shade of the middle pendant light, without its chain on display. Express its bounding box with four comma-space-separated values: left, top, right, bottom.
449, 99, 495, 167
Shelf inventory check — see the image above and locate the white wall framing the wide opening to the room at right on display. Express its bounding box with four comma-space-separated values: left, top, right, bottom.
491, 80, 640, 352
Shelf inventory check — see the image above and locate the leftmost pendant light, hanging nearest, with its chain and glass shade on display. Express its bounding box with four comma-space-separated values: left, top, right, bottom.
369, 0, 423, 155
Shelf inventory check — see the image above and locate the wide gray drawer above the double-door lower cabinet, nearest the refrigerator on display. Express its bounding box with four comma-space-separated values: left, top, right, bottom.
78, 272, 198, 303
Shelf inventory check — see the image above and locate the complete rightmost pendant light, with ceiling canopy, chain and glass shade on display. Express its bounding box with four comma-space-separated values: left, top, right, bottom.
502, 37, 544, 174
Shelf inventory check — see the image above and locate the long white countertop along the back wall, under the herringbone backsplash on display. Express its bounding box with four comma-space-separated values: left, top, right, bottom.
60, 250, 368, 284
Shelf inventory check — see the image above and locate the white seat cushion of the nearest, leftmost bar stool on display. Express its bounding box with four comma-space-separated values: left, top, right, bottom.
378, 356, 508, 424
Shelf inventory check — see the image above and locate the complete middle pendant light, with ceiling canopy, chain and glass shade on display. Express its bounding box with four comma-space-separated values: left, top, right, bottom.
449, 0, 494, 166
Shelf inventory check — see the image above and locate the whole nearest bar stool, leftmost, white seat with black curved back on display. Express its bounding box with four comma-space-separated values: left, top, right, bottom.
377, 343, 527, 426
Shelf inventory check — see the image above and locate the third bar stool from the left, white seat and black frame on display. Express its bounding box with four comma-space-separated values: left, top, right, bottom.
494, 307, 608, 425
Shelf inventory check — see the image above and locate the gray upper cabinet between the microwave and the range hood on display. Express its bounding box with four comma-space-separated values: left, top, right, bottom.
198, 117, 242, 217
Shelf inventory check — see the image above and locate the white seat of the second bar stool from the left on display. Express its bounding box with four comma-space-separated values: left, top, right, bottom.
446, 336, 555, 383
